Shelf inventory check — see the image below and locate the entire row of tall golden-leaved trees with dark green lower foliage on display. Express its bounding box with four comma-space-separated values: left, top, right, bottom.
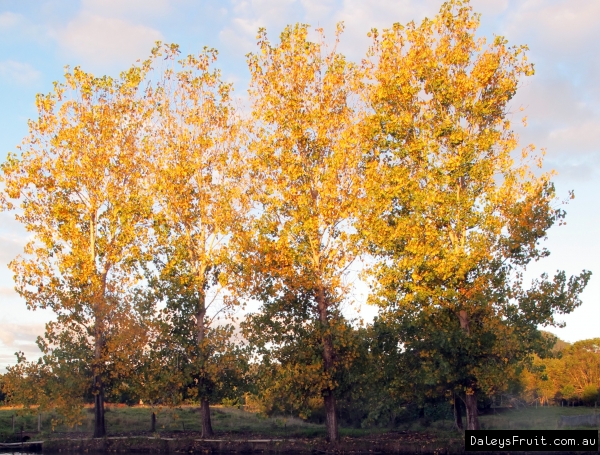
1, 0, 598, 441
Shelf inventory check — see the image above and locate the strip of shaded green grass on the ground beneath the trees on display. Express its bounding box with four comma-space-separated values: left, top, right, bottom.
0, 406, 596, 440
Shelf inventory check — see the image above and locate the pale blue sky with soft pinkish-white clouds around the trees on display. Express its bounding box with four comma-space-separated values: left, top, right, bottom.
0, 0, 600, 372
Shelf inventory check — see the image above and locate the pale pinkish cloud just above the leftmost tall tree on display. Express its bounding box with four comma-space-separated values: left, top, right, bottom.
56, 11, 163, 67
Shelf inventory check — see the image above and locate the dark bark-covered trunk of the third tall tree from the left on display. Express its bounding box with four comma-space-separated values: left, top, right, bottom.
317, 288, 339, 442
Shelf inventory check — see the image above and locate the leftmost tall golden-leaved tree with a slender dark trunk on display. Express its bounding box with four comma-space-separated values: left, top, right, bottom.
2, 64, 152, 437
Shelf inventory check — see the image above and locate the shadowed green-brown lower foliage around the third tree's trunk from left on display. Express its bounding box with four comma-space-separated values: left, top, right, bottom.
241, 296, 358, 426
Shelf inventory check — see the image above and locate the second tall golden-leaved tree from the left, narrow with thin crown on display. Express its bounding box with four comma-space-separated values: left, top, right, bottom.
145, 45, 247, 437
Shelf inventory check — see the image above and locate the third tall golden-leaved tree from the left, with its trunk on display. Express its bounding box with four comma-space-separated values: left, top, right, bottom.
242, 25, 364, 442
